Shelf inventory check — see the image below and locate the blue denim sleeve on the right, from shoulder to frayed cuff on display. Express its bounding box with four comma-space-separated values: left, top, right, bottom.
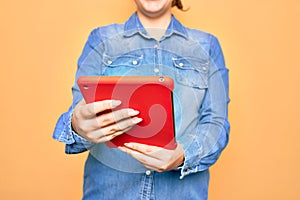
181, 36, 230, 178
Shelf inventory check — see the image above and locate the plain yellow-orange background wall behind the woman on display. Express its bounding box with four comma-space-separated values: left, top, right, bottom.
0, 0, 300, 200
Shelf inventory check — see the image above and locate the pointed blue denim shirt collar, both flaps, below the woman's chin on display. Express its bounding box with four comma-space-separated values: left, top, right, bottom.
124, 13, 188, 38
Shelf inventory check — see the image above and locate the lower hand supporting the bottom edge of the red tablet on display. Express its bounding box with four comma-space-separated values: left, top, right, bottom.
119, 143, 184, 172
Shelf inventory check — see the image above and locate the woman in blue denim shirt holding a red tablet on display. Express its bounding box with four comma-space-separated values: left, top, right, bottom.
53, 0, 229, 200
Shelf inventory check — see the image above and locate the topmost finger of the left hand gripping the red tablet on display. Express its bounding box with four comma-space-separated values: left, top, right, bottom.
82, 100, 122, 118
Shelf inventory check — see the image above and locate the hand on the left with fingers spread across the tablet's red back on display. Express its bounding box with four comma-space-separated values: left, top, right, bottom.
72, 100, 142, 143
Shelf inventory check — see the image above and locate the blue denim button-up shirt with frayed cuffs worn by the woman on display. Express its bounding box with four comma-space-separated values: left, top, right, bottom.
53, 13, 230, 199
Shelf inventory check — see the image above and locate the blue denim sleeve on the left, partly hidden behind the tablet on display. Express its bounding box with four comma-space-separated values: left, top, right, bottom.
52, 29, 102, 154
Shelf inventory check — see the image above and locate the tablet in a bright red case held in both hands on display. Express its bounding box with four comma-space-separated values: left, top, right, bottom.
77, 76, 177, 149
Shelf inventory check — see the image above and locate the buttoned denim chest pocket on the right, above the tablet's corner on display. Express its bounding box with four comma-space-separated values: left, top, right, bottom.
172, 57, 209, 89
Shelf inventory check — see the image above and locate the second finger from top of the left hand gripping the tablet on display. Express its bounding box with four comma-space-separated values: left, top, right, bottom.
97, 108, 139, 127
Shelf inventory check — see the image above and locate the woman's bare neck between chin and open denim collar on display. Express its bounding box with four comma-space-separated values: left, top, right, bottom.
137, 12, 172, 29
